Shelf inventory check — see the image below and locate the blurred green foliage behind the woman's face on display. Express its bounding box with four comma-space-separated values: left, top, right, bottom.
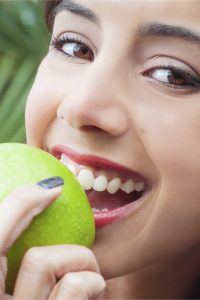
0, 0, 50, 143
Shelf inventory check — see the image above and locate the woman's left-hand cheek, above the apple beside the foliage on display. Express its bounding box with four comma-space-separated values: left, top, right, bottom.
25, 55, 81, 148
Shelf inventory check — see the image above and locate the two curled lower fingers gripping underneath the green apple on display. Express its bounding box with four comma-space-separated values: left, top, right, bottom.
14, 245, 105, 300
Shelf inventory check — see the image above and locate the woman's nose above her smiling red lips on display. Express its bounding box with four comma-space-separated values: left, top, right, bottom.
57, 63, 129, 136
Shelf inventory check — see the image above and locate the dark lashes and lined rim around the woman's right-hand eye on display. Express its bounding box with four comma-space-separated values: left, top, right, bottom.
143, 65, 200, 90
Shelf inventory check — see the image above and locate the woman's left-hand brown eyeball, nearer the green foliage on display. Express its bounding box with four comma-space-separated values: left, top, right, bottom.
61, 42, 94, 61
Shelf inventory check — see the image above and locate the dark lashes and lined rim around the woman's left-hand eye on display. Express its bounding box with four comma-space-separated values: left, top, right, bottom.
51, 36, 94, 61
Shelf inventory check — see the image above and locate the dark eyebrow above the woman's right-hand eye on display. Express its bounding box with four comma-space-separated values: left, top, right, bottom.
137, 22, 200, 44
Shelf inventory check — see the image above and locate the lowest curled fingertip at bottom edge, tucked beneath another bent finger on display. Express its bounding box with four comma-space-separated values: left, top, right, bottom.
49, 271, 106, 300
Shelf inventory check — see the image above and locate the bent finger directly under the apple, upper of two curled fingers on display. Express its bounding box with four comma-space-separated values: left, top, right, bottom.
14, 245, 99, 299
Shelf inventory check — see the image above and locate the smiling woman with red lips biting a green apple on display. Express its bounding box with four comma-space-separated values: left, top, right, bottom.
0, 0, 200, 299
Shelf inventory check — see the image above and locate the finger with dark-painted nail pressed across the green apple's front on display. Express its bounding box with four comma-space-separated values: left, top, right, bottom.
0, 180, 62, 255
